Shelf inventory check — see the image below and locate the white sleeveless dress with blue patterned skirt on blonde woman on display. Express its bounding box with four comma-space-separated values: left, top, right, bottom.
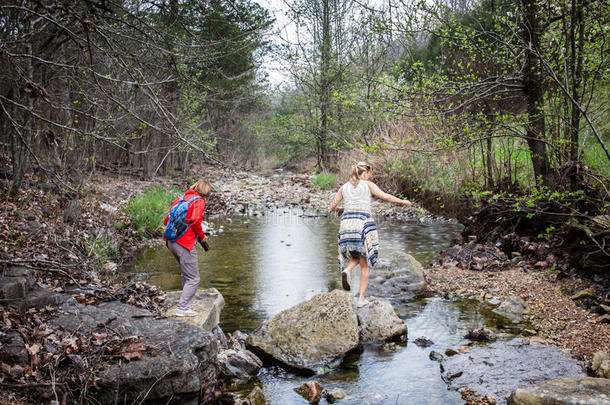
337, 180, 379, 271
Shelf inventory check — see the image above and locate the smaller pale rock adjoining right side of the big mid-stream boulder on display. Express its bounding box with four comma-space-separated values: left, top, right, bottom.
356, 297, 407, 342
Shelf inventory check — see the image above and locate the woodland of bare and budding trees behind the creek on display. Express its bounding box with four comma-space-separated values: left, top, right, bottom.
0, 0, 610, 274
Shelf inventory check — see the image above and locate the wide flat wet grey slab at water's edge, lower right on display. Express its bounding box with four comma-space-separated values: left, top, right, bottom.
441, 339, 585, 404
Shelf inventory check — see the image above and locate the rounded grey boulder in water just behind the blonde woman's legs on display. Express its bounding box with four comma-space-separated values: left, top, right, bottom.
367, 253, 426, 299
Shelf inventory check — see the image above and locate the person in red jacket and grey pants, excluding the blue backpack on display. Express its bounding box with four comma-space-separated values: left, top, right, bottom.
163, 179, 212, 316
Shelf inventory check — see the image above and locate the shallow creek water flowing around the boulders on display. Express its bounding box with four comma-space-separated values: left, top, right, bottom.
132, 210, 512, 404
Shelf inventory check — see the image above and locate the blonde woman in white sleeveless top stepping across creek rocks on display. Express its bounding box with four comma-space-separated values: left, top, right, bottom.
330, 162, 412, 308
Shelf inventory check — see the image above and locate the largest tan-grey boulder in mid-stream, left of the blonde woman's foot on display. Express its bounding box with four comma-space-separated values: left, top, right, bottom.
246, 290, 358, 372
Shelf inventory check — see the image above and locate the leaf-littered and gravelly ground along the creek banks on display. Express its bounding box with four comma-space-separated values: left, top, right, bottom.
0, 167, 610, 403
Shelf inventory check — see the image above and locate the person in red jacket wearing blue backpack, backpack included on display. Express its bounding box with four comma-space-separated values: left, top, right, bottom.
163, 179, 212, 316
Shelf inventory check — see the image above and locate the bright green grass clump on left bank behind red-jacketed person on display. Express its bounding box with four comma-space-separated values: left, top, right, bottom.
125, 186, 180, 237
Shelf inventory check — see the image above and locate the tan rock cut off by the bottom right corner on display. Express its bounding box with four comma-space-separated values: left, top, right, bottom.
508, 377, 610, 405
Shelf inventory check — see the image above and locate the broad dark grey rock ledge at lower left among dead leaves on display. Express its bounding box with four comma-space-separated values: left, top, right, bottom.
49, 301, 218, 404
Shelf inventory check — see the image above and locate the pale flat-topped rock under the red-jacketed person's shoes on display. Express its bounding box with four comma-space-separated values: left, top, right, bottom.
165, 288, 225, 331
